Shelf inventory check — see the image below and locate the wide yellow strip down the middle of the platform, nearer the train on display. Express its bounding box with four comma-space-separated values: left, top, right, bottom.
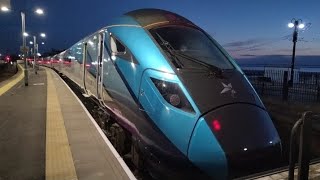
46, 69, 78, 180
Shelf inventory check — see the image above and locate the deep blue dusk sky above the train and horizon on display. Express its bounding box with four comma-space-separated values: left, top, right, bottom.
0, 0, 320, 64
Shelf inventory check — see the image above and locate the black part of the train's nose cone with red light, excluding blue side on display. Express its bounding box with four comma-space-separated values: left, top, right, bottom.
204, 103, 281, 177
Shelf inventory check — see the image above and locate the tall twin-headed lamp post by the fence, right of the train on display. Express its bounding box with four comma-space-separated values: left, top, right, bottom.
288, 19, 305, 87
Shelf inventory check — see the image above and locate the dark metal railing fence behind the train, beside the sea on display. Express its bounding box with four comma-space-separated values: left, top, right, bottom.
242, 67, 320, 103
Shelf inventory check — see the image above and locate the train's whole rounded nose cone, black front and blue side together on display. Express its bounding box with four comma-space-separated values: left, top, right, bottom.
188, 103, 281, 179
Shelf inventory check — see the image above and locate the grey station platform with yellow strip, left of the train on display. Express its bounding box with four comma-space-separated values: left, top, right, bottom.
0, 66, 136, 180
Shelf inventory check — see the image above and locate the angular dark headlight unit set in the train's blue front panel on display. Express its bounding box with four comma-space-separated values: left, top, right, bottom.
151, 78, 194, 112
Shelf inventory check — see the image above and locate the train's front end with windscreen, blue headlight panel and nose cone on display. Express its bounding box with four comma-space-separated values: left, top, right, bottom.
124, 10, 281, 179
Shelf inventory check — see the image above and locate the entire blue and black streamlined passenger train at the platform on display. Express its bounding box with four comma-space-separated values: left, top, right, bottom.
44, 9, 282, 179
